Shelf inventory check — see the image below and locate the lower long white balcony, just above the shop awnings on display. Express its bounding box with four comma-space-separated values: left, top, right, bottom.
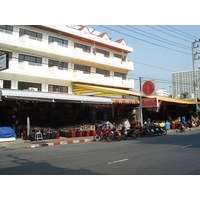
1, 59, 134, 89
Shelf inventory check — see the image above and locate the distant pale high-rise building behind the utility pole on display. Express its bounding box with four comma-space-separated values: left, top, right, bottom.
172, 67, 200, 98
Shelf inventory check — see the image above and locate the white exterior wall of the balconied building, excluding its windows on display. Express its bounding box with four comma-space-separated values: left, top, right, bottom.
0, 26, 134, 93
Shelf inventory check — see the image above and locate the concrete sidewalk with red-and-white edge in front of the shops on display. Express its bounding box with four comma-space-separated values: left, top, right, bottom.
0, 127, 200, 149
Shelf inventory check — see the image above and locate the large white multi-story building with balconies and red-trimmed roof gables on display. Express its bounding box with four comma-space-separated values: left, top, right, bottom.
0, 25, 134, 96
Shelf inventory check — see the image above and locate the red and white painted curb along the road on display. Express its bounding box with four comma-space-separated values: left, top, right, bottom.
23, 139, 93, 149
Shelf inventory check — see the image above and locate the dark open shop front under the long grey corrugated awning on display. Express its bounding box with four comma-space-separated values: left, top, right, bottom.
0, 89, 113, 137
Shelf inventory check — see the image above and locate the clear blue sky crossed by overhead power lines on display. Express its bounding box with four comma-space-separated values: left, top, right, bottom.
89, 25, 200, 92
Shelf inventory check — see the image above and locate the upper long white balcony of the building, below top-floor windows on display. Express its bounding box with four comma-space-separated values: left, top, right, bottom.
0, 30, 134, 71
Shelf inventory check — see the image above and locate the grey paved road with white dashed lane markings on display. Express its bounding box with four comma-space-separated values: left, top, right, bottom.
0, 130, 200, 175
